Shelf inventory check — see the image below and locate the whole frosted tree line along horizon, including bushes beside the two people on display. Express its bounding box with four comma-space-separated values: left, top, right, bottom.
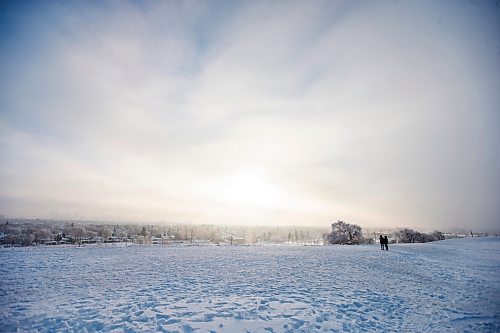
0, 219, 484, 246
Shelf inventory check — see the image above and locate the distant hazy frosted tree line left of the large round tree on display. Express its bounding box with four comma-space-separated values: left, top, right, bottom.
0, 219, 325, 246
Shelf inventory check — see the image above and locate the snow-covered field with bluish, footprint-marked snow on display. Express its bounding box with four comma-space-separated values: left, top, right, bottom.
0, 237, 500, 332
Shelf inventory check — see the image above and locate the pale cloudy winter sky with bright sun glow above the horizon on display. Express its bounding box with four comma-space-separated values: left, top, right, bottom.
0, 0, 500, 229
